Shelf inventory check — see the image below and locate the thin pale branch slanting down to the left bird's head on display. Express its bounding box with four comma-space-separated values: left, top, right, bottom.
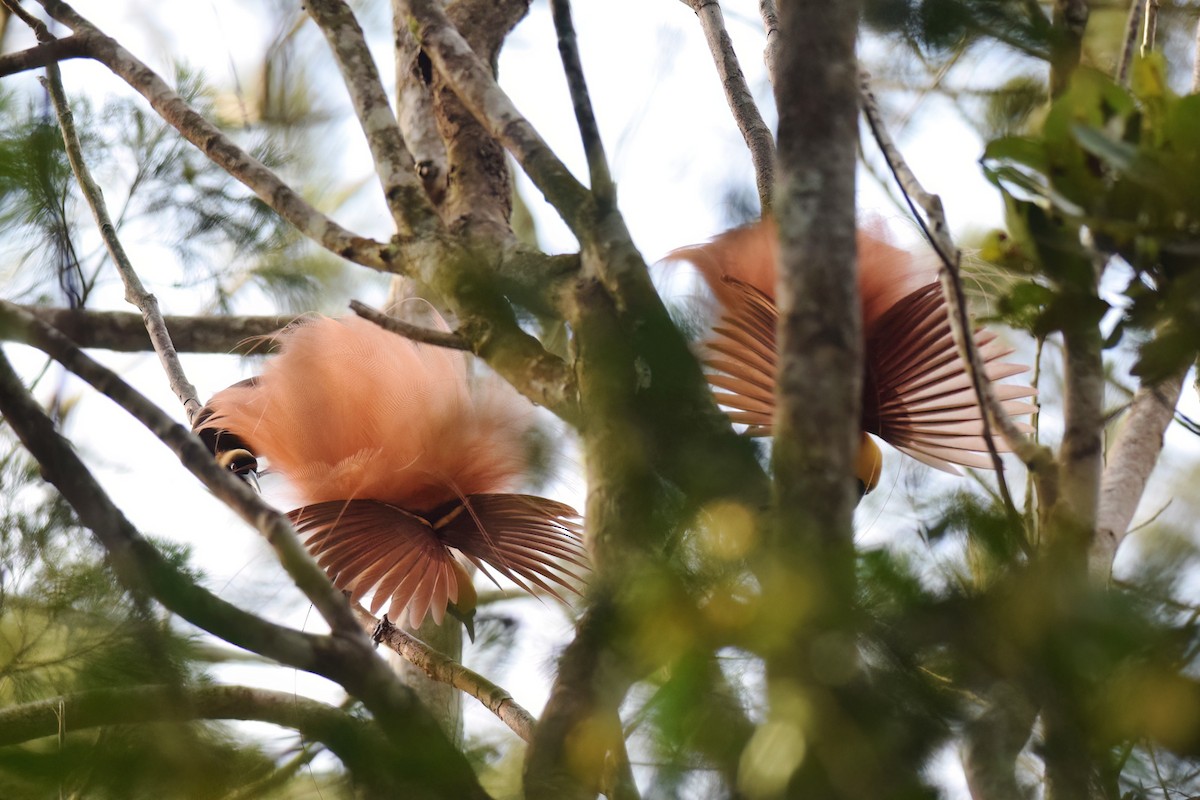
43, 64, 200, 421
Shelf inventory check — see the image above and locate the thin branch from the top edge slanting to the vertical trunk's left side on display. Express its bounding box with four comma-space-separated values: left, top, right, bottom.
683, 0, 779, 216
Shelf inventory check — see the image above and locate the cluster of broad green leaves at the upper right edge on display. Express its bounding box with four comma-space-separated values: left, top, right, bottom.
984, 56, 1200, 380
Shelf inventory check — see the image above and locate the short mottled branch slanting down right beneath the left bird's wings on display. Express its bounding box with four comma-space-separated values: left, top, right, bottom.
353, 604, 538, 741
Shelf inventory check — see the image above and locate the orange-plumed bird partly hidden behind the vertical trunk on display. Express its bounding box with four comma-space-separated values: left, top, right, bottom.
672, 219, 1036, 493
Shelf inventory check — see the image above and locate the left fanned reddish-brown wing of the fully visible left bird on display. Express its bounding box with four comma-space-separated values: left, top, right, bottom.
288, 500, 458, 627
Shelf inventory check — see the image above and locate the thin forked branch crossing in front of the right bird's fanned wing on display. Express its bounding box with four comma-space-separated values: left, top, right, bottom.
860, 72, 1049, 512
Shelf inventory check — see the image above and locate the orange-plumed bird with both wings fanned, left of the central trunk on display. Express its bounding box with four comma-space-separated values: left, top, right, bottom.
194, 318, 588, 636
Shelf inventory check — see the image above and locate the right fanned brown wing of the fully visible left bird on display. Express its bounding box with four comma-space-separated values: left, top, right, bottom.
430, 494, 588, 600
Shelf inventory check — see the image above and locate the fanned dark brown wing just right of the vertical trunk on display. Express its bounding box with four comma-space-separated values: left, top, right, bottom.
863, 284, 1036, 473
